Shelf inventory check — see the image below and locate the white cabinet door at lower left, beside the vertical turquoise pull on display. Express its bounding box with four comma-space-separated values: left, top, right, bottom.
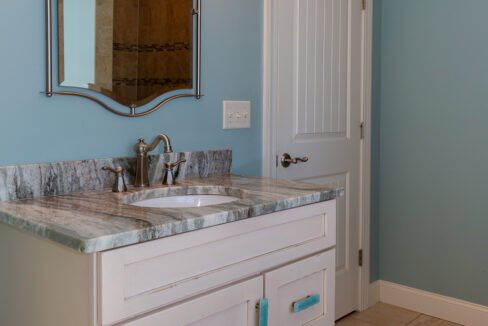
124, 277, 263, 326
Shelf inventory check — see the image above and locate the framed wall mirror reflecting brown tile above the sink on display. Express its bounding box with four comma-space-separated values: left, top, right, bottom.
46, 0, 201, 117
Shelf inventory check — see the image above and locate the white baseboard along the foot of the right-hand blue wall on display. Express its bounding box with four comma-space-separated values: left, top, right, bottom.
376, 281, 488, 326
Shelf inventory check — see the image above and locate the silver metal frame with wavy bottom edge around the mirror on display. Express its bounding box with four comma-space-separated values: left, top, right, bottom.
45, 0, 202, 118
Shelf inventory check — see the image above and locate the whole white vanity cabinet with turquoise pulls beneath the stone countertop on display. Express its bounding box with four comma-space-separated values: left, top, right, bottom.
0, 200, 336, 326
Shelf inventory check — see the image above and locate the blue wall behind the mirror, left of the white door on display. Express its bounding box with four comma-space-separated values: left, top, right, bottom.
0, 0, 262, 174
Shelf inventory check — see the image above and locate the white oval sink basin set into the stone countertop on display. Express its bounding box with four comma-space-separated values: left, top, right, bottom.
130, 195, 240, 208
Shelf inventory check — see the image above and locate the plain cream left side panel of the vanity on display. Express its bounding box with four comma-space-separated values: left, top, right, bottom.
0, 223, 95, 326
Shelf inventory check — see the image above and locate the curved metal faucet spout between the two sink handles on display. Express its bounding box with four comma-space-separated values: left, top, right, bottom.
134, 134, 173, 188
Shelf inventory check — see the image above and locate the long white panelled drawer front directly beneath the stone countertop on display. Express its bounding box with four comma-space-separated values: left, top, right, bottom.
98, 201, 335, 325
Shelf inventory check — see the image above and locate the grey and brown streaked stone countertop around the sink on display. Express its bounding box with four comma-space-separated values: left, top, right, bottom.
0, 175, 336, 253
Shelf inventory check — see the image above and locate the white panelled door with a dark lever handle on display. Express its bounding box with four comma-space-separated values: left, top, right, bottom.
270, 0, 362, 318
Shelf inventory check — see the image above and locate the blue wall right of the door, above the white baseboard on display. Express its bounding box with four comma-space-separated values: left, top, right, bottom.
376, 0, 488, 305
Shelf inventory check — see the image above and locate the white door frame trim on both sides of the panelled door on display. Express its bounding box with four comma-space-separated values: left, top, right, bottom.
262, 0, 374, 311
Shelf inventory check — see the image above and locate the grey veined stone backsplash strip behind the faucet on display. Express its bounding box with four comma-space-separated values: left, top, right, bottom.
0, 149, 232, 202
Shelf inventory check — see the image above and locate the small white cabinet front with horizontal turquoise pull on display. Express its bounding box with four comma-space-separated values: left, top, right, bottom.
265, 249, 335, 326
